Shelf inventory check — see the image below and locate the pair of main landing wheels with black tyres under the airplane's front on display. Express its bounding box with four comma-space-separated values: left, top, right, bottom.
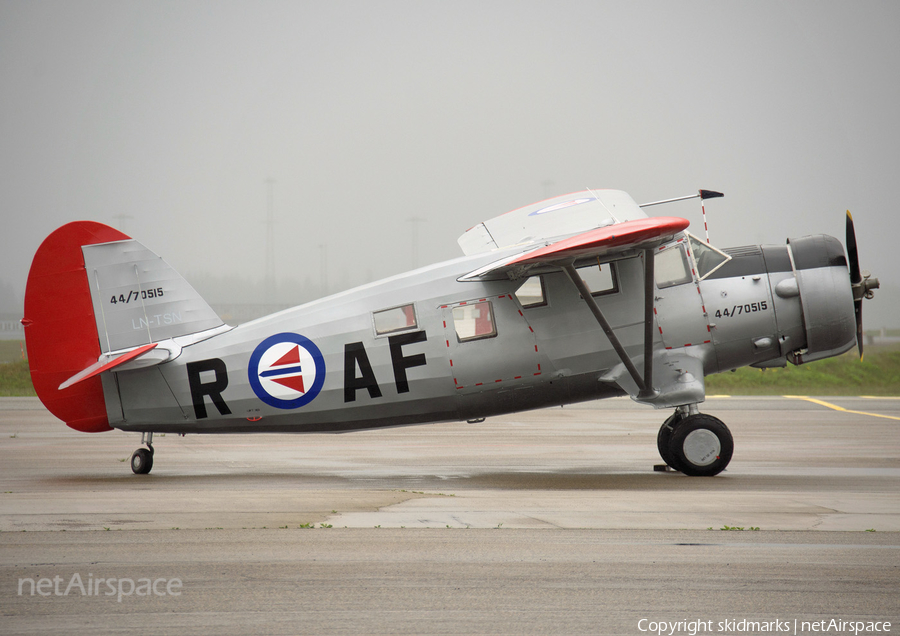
656, 405, 734, 477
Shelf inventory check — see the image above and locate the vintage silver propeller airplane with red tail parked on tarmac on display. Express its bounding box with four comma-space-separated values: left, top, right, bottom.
22, 190, 878, 475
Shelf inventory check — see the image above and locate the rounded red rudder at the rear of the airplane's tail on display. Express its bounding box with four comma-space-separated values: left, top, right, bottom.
22, 221, 129, 433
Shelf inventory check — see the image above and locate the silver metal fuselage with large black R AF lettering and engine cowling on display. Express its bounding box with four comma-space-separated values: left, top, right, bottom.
102, 231, 855, 433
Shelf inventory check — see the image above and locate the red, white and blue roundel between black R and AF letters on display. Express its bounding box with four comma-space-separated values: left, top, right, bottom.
247, 333, 325, 409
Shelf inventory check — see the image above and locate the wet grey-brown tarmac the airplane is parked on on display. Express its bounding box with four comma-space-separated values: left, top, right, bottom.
0, 397, 900, 634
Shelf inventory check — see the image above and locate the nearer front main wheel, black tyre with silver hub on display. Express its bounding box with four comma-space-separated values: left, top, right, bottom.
669, 413, 734, 477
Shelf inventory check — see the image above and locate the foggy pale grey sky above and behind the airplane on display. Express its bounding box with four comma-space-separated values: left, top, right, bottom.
0, 0, 900, 328
